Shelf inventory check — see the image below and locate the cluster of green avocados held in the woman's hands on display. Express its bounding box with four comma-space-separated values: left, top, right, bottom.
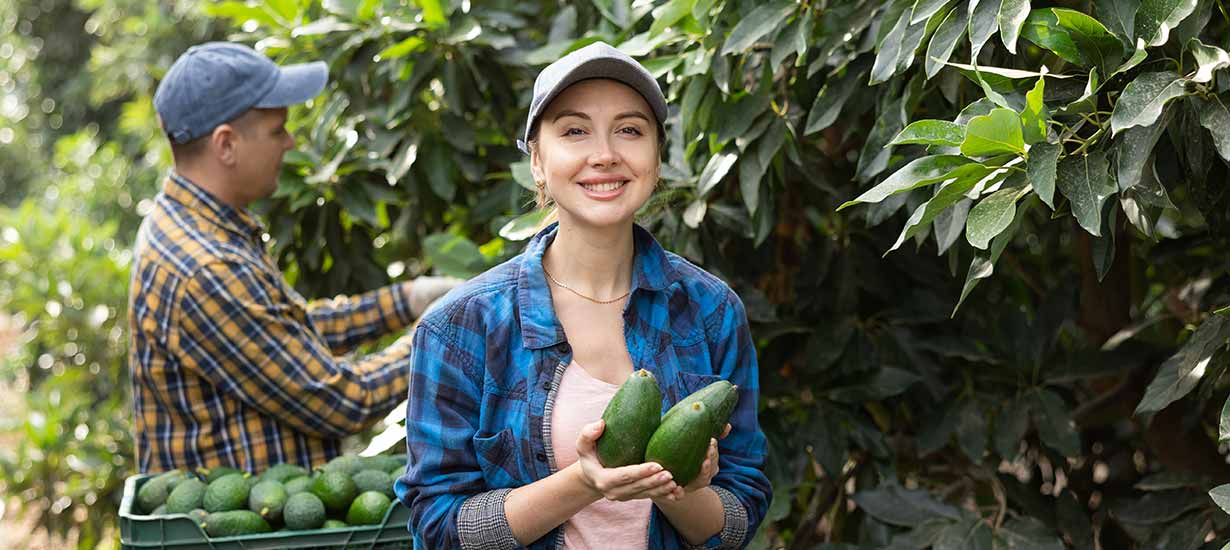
598, 369, 739, 486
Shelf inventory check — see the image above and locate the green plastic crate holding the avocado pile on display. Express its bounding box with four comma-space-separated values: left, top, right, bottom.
119, 474, 412, 550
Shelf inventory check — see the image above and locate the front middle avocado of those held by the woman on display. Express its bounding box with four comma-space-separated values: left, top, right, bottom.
645, 401, 713, 487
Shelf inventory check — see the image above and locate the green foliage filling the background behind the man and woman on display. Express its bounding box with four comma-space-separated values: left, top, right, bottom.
7, 0, 1230, 550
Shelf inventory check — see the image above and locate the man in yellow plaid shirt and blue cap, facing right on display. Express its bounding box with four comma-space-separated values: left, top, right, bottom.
128, 43, 458, 472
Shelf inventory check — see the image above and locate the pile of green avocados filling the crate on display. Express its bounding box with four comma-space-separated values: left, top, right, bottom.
134, 455, 406, 538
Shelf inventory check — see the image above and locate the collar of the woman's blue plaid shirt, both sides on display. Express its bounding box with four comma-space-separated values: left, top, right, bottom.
517, 223, 678, 349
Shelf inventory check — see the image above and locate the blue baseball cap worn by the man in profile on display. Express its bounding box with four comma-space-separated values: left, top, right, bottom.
154, 42, 328, 144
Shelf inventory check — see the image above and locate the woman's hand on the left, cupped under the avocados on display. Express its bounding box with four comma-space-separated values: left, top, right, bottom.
577, 420, 683, 501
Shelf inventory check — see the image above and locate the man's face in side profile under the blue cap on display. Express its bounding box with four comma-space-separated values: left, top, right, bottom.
235, 108, 295, 202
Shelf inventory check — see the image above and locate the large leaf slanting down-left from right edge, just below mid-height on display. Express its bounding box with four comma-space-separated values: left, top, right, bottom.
1135, 315, 1230, 415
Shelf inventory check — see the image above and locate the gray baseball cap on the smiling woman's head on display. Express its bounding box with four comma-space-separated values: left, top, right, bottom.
517, 42, 667, 154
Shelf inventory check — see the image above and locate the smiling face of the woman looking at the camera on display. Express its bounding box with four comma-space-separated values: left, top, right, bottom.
530, 79, 659, 226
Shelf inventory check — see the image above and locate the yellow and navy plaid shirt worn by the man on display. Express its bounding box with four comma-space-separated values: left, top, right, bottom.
128, 173, 413, 472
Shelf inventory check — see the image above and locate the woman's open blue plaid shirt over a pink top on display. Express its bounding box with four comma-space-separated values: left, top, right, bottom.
395, 225, 771, 550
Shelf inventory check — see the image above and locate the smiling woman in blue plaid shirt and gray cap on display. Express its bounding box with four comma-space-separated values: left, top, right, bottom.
396, 43, 770, 550
